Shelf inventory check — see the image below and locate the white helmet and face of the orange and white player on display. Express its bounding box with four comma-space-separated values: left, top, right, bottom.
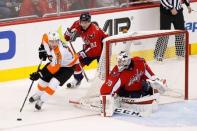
48, 31, 60, 49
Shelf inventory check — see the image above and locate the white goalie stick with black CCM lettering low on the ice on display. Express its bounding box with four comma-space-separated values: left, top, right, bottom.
69, 100, 150, 117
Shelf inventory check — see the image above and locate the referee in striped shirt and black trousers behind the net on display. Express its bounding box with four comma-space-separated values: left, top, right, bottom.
154, 0, 192, 61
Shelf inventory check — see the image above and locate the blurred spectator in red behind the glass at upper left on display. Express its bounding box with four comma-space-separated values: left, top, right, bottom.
19, 0, 56, 17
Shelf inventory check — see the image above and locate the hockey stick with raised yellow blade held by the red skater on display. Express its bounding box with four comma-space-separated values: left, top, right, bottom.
57, 26, 89, 82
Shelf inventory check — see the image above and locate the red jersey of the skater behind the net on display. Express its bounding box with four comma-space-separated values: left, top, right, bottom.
64, 20, 108, 57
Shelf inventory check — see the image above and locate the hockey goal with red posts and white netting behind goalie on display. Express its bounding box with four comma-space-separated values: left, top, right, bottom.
84, 30, 189, 103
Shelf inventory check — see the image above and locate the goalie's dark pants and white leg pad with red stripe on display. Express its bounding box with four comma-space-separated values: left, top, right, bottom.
117, 81, 159, 114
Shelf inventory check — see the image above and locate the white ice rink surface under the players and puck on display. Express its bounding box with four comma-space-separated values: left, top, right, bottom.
0, 56, 197, 131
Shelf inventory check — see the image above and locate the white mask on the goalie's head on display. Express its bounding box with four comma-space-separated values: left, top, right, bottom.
117, 51, 131, 71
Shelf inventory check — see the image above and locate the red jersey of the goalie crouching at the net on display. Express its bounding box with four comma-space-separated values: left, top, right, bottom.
100, 57, 154, 95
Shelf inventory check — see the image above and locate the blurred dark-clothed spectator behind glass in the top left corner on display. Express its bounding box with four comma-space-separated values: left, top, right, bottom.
0, 0, 17, 18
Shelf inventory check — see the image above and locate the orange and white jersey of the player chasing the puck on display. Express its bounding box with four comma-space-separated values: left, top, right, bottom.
42, 34, 79, 74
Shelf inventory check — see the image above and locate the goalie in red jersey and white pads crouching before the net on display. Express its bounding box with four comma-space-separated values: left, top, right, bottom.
100, 51, 167, 116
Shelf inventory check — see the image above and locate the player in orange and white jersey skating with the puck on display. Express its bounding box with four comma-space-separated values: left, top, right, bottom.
29, 32, 79, 110
